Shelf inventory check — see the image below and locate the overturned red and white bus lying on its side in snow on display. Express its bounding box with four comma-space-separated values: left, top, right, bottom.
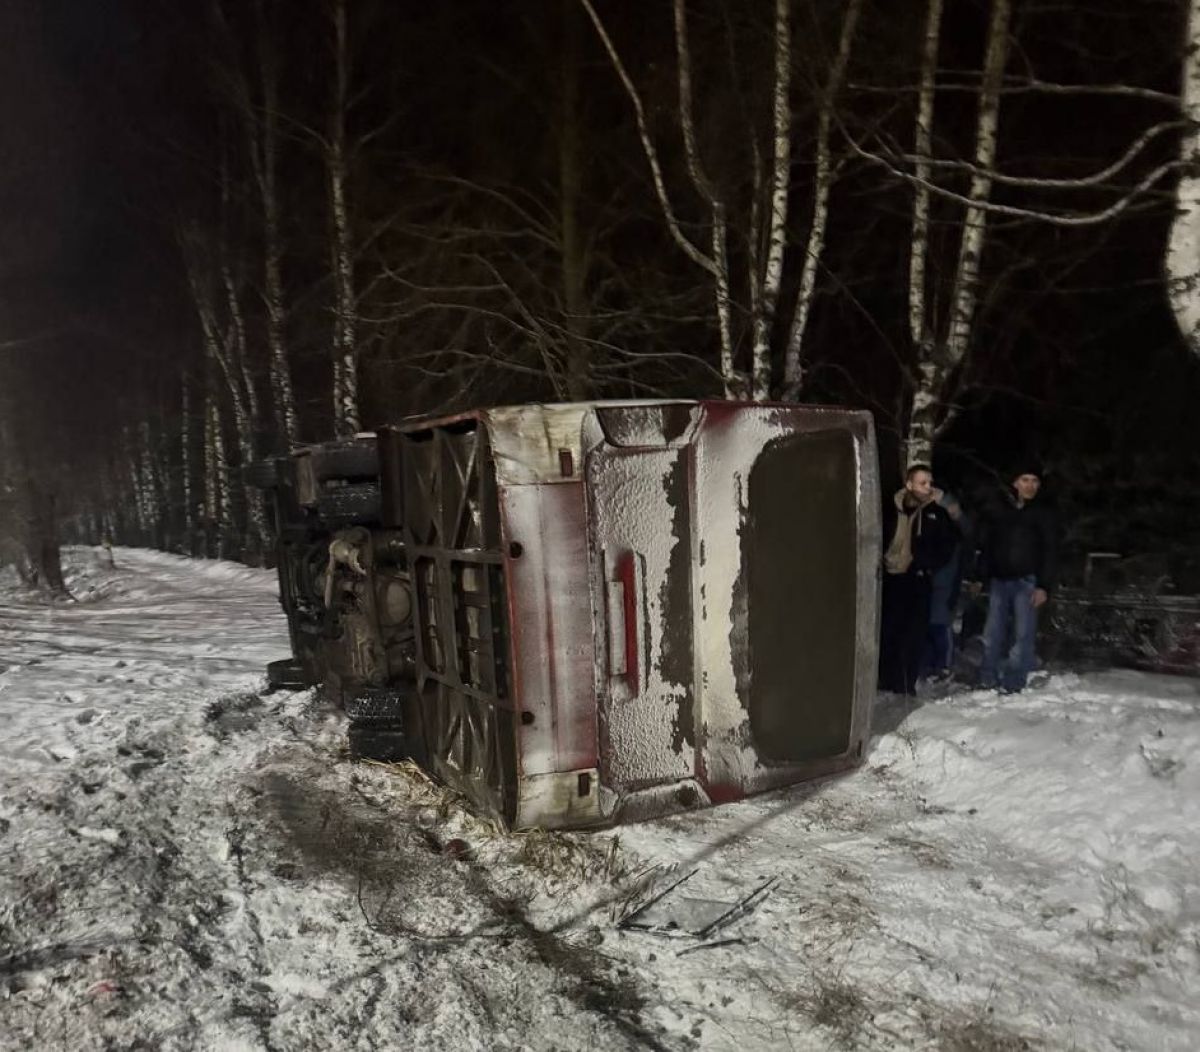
254, 402, 880, 828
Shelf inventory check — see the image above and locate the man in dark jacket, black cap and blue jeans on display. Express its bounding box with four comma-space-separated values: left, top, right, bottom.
979, 463, 1058, 693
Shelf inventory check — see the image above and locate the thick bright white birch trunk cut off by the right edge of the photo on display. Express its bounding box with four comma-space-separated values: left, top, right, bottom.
1166, 0, 1200, 355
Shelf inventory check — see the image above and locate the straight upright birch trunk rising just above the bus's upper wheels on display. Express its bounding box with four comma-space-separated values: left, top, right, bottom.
325, 0, 361, 437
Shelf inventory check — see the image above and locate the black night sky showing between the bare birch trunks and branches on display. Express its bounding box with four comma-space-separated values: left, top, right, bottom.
0, 0, 1200, 570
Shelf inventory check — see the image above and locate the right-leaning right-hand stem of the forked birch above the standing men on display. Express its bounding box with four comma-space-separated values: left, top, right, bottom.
905, 0, 1012, 464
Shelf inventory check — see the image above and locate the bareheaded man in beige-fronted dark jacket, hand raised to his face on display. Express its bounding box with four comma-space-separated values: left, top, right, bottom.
880, 464, 958, 695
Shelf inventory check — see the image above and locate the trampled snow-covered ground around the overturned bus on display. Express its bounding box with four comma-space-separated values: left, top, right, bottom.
0, 549, 1200, 1052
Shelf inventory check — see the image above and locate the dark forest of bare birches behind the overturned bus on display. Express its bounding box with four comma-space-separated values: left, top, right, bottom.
0, 0, 1200, 587
